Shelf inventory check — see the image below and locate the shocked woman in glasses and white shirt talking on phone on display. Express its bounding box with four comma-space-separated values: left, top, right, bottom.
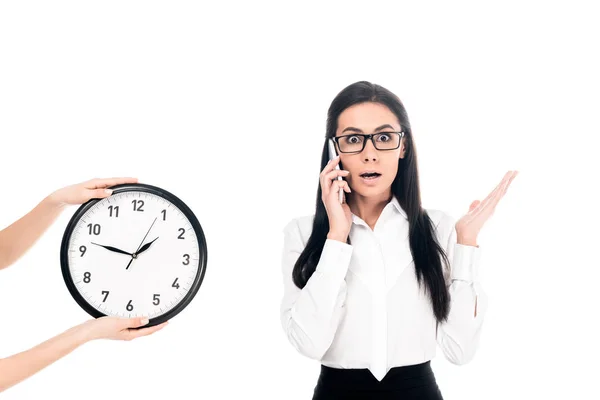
281, 82, 516, 399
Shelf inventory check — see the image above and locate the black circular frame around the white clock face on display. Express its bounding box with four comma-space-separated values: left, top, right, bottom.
60, 183, 208, 328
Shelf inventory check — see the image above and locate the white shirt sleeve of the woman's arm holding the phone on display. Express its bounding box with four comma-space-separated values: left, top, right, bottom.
281, 220, 352, 360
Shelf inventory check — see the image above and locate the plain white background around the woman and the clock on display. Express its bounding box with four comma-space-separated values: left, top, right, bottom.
0, 1, 600, 400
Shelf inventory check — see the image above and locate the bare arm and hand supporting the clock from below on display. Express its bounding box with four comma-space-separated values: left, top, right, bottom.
0, 317, 167, 392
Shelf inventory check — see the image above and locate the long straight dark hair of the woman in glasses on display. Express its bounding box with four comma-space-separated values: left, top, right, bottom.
292, 81, 450, 322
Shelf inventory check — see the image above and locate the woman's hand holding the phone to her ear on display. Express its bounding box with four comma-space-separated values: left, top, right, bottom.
319, 156, 352, 243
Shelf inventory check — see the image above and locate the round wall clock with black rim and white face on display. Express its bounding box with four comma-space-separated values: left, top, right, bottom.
60, 183, 207, 327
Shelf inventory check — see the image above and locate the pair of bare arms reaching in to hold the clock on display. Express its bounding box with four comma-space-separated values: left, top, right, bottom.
0, 178, 167, 392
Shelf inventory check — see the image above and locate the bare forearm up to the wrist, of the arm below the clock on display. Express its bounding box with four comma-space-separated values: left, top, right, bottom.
0, 324, 90, 392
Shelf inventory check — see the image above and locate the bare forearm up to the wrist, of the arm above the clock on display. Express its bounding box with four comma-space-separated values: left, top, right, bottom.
0, 196, 63, 269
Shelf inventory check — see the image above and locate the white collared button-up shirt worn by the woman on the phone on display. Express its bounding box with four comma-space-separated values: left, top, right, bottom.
281, 197, 488, 380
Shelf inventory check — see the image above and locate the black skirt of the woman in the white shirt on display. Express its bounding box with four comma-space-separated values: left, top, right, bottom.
313, 361, 443, 400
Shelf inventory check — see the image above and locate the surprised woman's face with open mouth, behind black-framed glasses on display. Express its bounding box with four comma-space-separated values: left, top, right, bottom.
336, 103, 405, 197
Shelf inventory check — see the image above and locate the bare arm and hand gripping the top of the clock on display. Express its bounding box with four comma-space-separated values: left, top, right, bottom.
0, 178, 137, 269
